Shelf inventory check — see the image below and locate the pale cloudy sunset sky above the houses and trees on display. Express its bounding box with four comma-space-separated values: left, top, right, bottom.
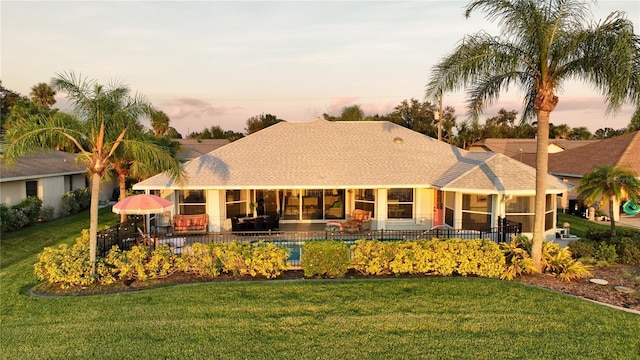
0, 0, 640, 136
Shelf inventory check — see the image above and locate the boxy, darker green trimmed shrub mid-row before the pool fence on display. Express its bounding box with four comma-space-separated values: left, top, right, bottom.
301, 240, 349, 278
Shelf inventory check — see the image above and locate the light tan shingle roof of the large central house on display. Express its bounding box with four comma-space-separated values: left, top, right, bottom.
134, 120, 564, 192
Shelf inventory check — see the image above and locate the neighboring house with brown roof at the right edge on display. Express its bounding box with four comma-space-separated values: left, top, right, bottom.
534, 131, 640, 220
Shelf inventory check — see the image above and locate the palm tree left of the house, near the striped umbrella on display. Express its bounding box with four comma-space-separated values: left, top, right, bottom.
5, 72, 182, 273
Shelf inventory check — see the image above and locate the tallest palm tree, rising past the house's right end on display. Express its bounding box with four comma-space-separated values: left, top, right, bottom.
426, 0, 640, 269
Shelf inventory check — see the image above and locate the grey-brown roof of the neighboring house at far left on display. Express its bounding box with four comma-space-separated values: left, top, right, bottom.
0, 151, 86, 182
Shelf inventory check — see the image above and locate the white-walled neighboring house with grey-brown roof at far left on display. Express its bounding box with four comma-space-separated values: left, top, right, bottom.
0, 151, 88, 214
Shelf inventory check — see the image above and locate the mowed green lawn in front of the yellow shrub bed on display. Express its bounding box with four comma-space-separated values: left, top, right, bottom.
0, 210, 640, 360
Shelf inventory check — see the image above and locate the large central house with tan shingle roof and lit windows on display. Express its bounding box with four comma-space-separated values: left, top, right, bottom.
133, 119, 567, 238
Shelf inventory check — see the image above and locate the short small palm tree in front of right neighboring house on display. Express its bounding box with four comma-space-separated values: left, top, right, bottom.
577, 165, 640, 236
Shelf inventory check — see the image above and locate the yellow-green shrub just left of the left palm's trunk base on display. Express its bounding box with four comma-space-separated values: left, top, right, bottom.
33, 230, 95, 289
